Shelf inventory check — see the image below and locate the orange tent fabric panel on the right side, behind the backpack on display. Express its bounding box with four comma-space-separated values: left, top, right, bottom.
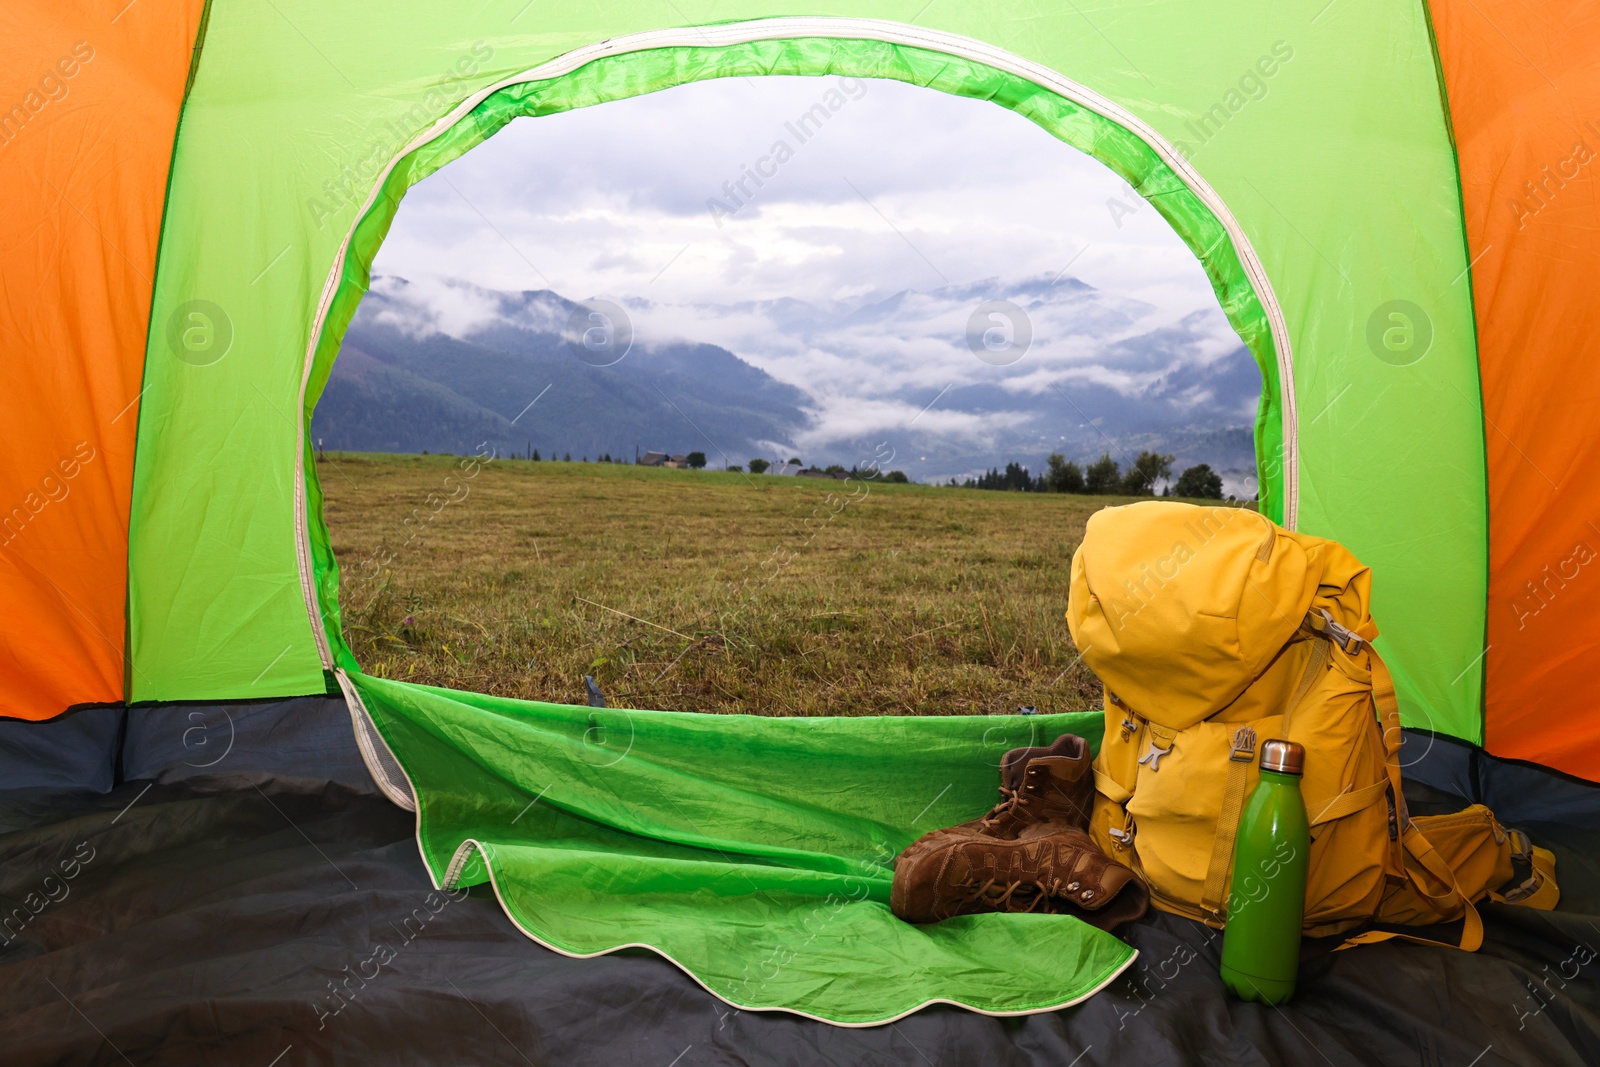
1432, 0, 1600, 777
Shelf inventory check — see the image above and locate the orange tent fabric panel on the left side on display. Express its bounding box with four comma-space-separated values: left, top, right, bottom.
0, 0, 203, 718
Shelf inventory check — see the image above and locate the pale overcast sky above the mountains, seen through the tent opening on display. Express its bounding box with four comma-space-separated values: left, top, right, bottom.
374, 77, 1250, 463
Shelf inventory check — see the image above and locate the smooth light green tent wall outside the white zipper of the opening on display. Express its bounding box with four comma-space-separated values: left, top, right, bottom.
130, 0, 1486, 741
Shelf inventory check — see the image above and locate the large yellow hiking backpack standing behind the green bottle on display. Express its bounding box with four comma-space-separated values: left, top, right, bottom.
1067, 501, 1558, 952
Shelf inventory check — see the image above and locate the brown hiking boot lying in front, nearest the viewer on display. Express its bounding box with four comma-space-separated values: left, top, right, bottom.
890, 827, 1150, 929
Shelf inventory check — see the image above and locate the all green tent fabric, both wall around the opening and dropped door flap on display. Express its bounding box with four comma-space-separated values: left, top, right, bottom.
96, 0, 1486, 1024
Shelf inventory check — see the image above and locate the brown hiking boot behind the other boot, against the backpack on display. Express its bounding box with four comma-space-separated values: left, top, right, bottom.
906, 734, 1094, 853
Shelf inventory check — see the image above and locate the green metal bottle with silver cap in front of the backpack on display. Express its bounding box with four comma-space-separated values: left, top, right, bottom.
1222, 741, 1310, 1005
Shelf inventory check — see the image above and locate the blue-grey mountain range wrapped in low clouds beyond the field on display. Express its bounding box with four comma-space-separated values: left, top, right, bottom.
312, 277, 1261, 483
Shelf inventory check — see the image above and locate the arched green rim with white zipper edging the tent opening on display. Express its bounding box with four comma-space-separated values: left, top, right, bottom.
296, 18, 1298, 684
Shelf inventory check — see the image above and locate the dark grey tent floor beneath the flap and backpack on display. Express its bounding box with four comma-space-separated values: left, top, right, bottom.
0, 697, 1600, 1067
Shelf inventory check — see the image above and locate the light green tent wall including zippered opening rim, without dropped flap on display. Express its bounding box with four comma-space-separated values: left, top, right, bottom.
126, 0, 1486, 751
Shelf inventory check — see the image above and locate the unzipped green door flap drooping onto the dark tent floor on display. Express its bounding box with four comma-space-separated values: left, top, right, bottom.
347, 673, 1136, 1025
